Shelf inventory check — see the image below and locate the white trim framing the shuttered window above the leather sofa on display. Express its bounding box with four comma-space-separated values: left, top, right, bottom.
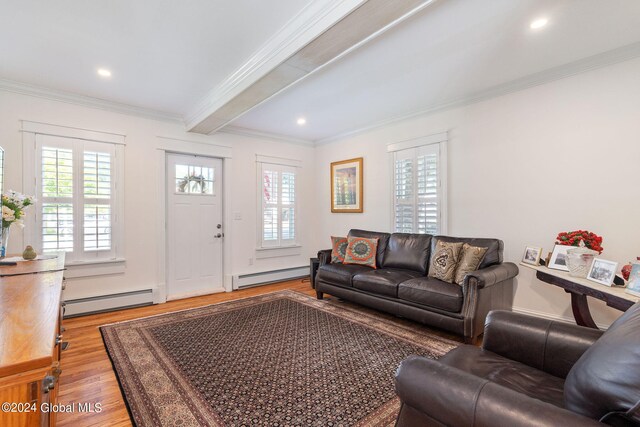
387, 132, 449, 235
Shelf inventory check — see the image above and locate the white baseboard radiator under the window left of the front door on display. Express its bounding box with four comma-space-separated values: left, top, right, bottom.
64, 289, 153, 317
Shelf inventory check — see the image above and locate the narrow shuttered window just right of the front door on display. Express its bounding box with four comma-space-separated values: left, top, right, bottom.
258, 162, 296, 248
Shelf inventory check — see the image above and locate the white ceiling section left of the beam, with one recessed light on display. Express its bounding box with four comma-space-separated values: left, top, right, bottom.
0, 0, 311, 116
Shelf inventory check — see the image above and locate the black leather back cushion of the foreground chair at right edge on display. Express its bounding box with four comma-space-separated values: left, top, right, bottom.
564, 303, 640, 423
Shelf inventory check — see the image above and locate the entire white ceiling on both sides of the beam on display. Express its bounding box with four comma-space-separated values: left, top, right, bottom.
0, 0, 640, 141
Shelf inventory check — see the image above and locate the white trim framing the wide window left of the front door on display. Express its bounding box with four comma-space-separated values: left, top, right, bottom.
22, 120, 126, 270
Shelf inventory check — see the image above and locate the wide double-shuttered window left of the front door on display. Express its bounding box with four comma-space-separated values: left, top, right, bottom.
35, 134, 122, 262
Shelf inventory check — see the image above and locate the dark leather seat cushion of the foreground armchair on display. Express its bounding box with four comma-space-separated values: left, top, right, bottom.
438, 345, 564, 410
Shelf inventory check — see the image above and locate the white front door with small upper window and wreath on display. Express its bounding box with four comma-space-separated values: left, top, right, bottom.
167, 154, 224, 300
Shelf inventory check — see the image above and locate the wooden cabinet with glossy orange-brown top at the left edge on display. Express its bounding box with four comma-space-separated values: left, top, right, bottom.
0, 253, 64, 427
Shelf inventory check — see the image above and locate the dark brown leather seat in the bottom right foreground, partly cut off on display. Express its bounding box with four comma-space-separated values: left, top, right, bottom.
396, 303, 640, 427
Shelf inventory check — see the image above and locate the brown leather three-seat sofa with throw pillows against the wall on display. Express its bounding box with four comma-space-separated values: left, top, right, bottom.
315, 230, 518, 342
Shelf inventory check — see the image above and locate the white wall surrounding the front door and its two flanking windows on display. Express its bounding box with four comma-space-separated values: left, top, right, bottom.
0, 91, 317, 299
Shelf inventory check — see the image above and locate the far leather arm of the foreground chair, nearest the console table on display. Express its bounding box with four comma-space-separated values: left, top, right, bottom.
482, 310, 603, 378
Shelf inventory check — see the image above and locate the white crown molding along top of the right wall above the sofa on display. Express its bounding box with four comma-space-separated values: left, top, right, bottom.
314, 42, 640, 146
